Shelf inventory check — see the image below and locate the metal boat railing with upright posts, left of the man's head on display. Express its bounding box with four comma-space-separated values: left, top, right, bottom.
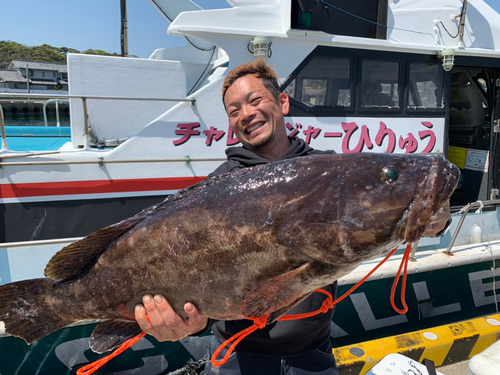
0, 93, 196, 151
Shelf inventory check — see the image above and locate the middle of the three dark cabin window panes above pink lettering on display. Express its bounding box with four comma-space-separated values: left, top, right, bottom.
361, 60, 399, 109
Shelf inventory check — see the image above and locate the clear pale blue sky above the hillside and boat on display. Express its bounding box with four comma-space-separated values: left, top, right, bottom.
0, 0, 500, 58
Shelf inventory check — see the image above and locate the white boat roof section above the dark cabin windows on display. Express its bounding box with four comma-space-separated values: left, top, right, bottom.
169, 0, 500, 55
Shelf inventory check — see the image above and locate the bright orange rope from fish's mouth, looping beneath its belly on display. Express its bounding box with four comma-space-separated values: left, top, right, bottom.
210, 244, 411, 366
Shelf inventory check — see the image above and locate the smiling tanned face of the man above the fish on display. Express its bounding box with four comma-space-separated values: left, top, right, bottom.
224, 75, 289, 152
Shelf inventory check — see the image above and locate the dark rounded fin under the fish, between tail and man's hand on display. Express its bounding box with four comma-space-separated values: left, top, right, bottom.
89, 320, 142, 354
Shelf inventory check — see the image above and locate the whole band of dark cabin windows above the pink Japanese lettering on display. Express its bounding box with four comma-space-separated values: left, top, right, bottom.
281, 46, 446, 117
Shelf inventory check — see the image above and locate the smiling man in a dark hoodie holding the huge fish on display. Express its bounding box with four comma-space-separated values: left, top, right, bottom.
135, 60, 449, 375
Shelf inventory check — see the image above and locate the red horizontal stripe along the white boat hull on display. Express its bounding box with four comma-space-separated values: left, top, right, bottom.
0, 177, 205, 199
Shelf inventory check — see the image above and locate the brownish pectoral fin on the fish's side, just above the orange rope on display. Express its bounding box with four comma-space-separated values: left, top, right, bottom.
241, 263, 310, 321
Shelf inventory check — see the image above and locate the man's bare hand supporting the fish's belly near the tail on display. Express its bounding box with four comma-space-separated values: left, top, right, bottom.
135, 295, 208, 341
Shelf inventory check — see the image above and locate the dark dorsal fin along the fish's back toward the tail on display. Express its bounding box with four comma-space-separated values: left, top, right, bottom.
44, 180, 212, 282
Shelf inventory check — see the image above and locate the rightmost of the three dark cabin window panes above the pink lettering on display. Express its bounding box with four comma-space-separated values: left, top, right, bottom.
407, 63, 444, 110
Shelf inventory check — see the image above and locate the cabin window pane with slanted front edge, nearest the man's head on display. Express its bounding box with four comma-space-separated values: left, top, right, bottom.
283, 56, 351, 109
